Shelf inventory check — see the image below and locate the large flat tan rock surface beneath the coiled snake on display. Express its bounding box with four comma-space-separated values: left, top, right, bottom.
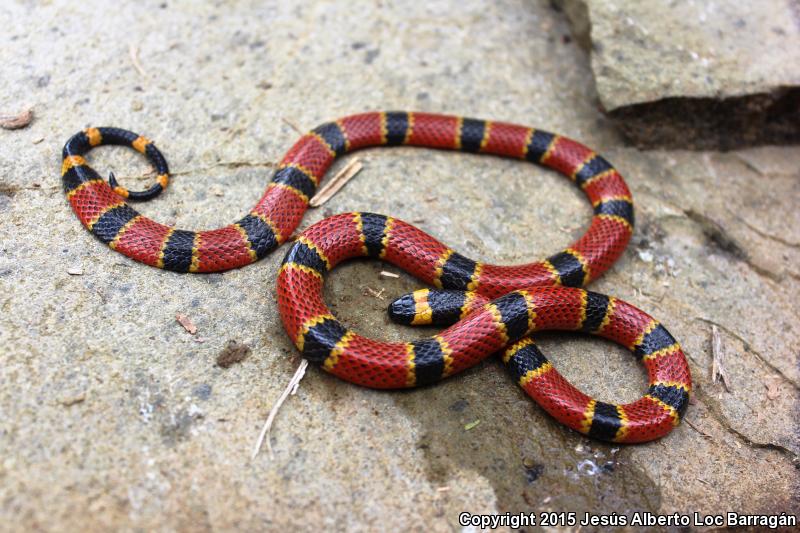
0, 0, 800, 531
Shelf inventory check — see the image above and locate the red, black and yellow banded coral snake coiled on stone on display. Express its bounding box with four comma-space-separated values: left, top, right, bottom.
62, 112, 691, 443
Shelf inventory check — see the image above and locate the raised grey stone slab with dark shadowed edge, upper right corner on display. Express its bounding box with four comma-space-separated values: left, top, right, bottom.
555, 0, 800, 148
